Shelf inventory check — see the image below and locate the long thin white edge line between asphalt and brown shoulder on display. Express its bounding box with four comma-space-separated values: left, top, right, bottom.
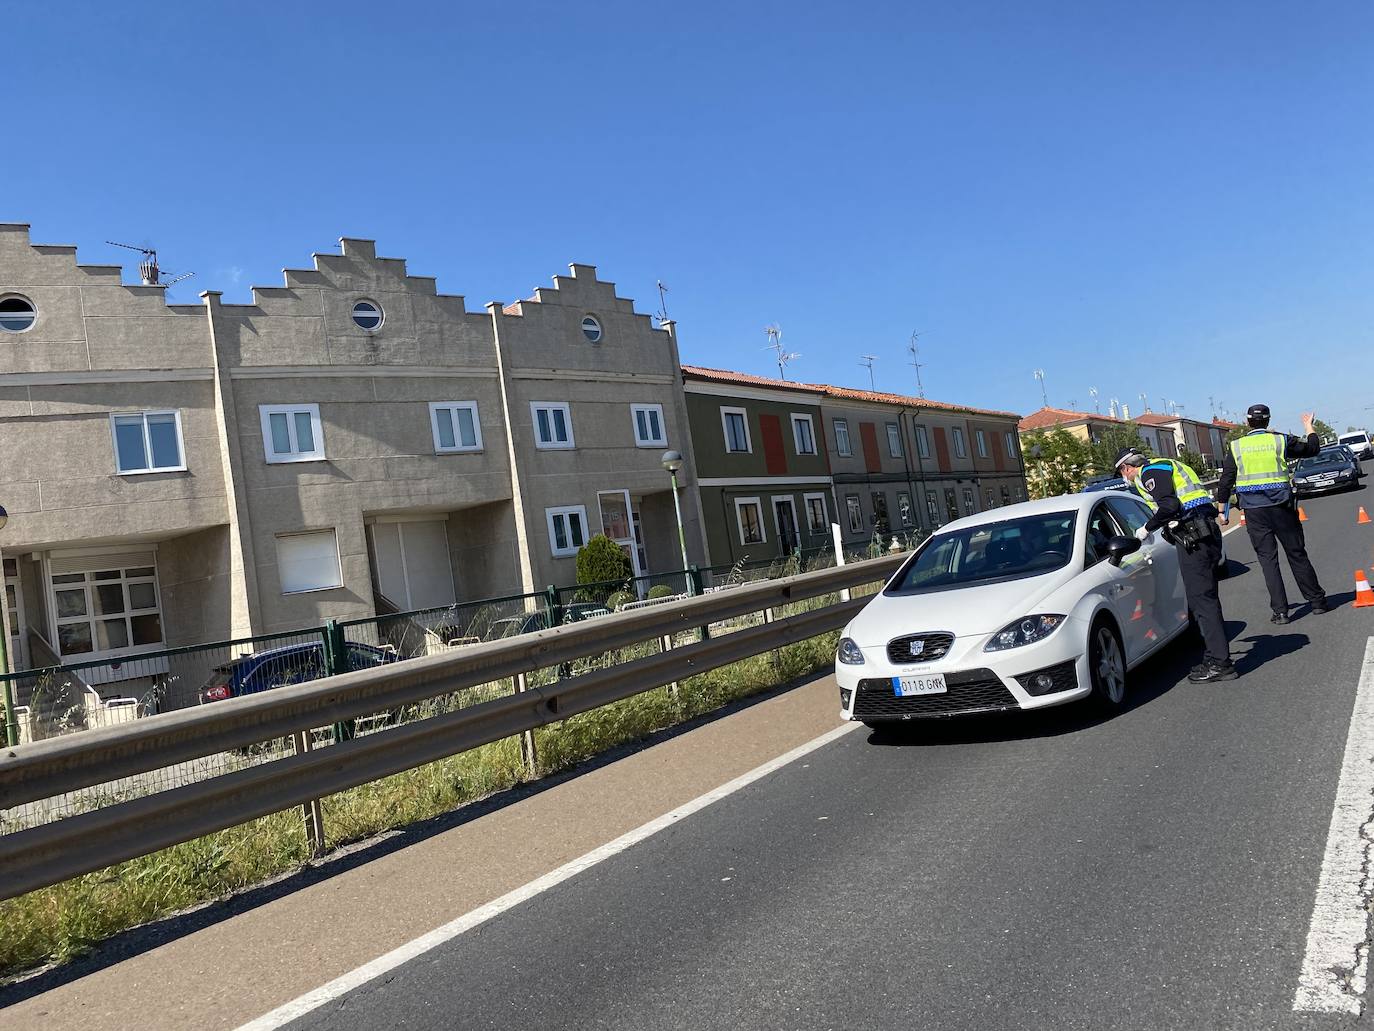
238, 723, 861, 1031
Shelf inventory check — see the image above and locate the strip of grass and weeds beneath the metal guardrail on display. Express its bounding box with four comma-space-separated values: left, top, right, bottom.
0, 634, 838, 977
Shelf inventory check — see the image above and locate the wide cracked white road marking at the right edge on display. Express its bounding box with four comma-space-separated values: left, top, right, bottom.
1293, 638, 1374, 1016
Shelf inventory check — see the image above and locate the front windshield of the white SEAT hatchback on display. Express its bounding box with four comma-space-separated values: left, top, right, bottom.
886, 511, 1077, 595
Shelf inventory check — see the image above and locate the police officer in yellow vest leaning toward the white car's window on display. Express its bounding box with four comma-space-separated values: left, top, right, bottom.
1117, 447, 1237, 683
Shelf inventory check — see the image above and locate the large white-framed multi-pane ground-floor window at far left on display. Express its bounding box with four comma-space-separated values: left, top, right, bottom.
52, 554, 162, 658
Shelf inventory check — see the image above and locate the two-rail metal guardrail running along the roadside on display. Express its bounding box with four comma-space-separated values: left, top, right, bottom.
0, 555, 907, 899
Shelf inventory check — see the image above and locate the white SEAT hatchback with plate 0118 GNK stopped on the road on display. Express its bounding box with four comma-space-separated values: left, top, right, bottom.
835, 491, 1189, 727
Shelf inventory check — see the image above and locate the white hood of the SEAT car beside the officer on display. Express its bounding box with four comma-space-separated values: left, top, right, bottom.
846, 564, 1077, 647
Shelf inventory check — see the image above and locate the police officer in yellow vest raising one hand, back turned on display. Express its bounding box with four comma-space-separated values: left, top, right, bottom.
1216, 404, 1327, 624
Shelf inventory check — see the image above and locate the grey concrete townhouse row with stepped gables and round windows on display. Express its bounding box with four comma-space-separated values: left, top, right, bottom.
0, 225, 705, 695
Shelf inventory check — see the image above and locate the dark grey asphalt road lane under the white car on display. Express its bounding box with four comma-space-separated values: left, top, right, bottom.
276, 489, 1374, 1031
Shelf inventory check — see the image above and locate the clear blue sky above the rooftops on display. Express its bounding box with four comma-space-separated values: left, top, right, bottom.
0, 0, 1374, 429
